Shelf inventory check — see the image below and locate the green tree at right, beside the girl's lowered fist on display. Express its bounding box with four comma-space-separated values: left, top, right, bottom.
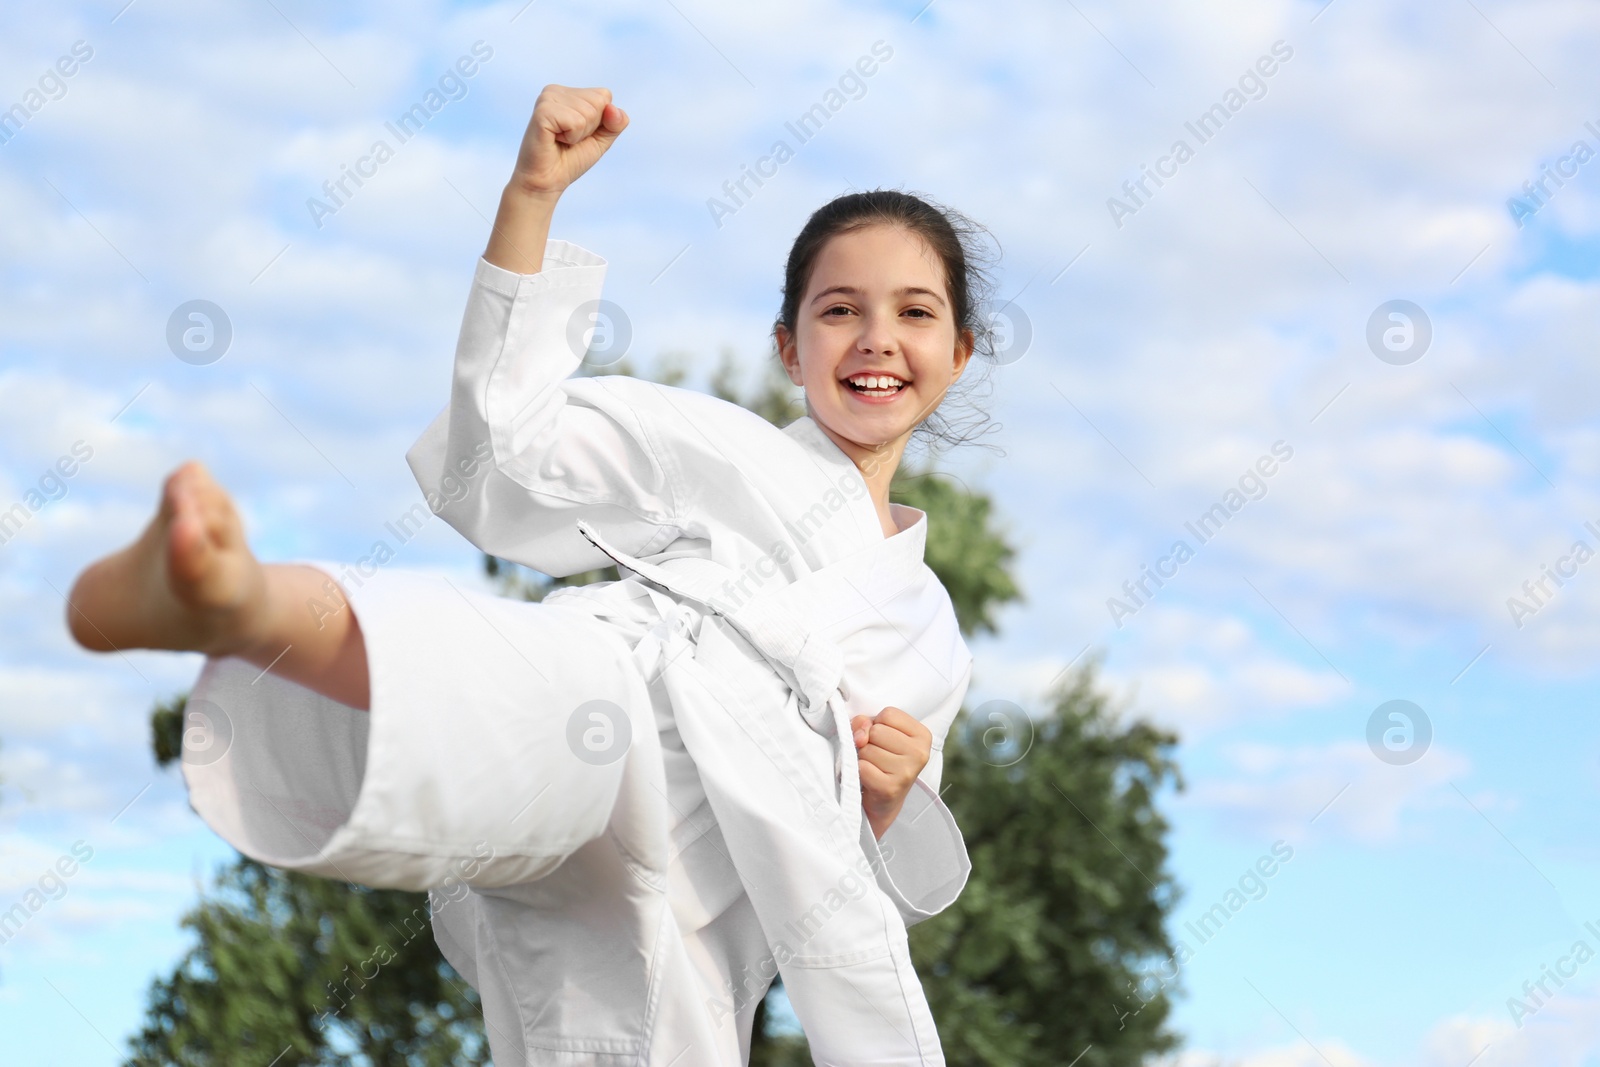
910, 665, 1182, 1067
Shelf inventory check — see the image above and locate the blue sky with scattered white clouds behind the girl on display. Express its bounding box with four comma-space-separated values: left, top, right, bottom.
0, 0, 1600, 1067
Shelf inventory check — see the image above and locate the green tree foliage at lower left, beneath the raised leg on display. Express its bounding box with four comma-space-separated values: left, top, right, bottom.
126, 697, 488, 1067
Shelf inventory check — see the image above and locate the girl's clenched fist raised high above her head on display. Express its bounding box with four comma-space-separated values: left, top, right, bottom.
512, 85, 627, 197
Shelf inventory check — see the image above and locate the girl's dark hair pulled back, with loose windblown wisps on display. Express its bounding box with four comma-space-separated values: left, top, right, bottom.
773, 189, 998, 453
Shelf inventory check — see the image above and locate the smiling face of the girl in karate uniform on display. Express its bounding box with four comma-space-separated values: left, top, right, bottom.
774, 224, 973, 458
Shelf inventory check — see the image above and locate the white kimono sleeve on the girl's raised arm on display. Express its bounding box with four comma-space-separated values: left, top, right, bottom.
406, 240, 680, 576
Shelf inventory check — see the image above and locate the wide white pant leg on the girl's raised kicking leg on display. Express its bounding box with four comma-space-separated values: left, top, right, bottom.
184, 563, 653, 889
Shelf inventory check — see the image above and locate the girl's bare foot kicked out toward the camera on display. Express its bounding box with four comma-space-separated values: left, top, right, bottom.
67, 461, 267, 656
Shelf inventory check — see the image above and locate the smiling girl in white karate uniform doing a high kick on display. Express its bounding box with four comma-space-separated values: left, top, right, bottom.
78, 85, 987, 1067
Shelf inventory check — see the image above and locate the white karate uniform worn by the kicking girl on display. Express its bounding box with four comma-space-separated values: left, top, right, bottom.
184, 240, 971, 1067
